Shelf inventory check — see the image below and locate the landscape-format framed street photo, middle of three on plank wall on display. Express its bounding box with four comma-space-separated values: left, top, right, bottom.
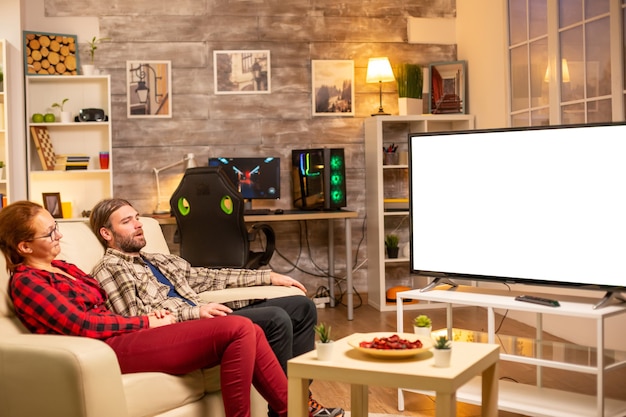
213, 51, 272, 94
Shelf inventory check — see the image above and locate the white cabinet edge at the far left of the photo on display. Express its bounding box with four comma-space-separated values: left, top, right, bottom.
0, 39, 11, 207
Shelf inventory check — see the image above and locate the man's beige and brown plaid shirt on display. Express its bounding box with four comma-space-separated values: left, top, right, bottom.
92, 248, 271, 321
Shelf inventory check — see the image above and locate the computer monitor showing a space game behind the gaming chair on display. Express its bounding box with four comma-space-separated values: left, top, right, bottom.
209, 157, 280, 210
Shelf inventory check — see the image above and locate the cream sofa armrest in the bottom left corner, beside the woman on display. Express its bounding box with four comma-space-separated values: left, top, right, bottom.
0, 334, 128, 417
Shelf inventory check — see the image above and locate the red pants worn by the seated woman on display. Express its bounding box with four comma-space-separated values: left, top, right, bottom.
105, 315, 287, 417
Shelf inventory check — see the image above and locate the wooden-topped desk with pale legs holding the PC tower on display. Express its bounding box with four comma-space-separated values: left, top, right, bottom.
152, 210, 357, 320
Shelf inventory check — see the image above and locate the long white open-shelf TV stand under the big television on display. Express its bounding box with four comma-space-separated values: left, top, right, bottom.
397, 287, 626, 417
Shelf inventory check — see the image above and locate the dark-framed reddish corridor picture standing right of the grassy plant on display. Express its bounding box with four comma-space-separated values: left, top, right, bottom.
429, 61, 467, 114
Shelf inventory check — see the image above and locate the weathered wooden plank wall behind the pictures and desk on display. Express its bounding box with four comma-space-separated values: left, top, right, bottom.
45, 0, 456, 293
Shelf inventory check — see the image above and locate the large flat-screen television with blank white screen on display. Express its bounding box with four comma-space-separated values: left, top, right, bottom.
409, 123, 626, 307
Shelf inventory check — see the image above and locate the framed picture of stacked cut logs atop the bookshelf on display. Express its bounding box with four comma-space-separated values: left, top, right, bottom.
23, 31, 80, 75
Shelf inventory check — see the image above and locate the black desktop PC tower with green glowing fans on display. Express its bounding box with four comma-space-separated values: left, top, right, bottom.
291, 148, 346, 210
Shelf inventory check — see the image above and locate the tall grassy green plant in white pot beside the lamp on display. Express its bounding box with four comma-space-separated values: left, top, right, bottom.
394, 63, 424, 116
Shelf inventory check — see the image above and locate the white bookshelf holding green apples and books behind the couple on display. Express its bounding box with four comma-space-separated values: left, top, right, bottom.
26, 75, 113, 218
